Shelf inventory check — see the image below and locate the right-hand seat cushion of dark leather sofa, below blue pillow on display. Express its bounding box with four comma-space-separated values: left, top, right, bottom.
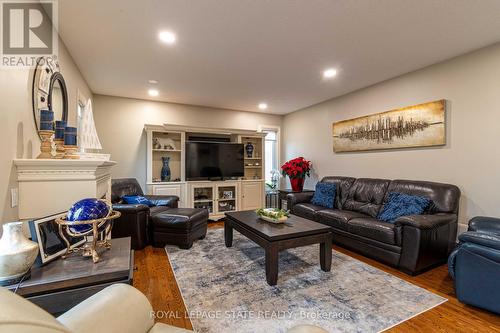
347, 217, 401, 245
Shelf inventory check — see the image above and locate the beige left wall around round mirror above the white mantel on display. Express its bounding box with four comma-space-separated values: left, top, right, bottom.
0, 40, 92, 220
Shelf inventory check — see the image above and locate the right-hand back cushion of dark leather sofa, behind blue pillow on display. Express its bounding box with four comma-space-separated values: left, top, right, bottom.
384, 179, 460, 214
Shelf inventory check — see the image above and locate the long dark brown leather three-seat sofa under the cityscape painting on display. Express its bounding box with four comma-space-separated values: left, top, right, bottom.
287, 177, 460, 275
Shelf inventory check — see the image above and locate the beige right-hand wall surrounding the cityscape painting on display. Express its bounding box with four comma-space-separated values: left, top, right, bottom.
283, 44, 500, 230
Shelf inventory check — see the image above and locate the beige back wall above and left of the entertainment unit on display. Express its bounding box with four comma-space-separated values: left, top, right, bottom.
93, 95, 282, 190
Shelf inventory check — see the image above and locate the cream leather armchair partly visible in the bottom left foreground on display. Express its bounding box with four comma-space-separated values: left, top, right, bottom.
0, 284, 191, 333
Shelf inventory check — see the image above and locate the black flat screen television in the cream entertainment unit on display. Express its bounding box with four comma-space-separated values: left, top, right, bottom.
186, 141, 245, 180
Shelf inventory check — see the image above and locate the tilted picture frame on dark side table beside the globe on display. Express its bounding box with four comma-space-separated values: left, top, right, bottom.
29, 213, 85, 264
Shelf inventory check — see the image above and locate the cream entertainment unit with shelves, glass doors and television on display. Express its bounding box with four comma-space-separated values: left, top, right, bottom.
144, 124, 266, 220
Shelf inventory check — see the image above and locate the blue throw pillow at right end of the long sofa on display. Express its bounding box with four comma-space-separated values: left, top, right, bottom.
377, 192, 431, 223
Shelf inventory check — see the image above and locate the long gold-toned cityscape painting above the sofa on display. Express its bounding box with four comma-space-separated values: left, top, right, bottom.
332, 99, 446, 153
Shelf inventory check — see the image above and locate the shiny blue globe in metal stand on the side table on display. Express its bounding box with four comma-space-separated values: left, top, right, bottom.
67, 198, 109, 233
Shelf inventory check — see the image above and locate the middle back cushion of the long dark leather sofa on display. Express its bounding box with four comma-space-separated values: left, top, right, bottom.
342, 178, 390, 217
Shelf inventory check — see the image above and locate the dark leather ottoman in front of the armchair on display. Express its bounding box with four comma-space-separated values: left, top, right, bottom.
150, 208, 208, 249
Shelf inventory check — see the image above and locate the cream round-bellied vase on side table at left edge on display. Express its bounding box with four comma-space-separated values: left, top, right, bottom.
0, 222, 38, 286
